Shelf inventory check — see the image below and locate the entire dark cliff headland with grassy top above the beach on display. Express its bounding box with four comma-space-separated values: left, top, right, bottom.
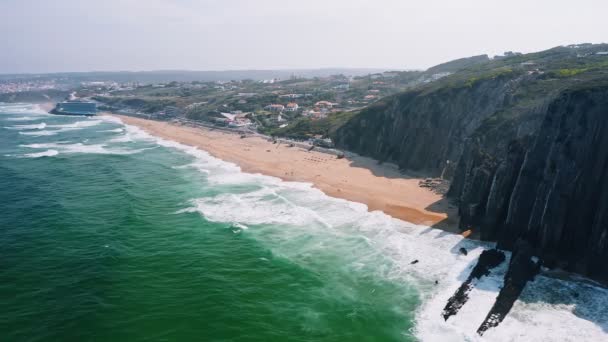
333, 45, 608, 280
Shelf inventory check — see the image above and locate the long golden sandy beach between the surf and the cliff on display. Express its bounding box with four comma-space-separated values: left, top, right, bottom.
107, 114, 459, 232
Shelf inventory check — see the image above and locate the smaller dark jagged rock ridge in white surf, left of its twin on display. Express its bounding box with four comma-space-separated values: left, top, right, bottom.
442, 249, 505, 321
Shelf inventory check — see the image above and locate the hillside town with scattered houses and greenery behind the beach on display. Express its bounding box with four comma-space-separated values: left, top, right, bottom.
0, 71, 442, 144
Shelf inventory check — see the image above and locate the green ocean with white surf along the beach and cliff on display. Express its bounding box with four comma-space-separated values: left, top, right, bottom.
0, 104, 608, 341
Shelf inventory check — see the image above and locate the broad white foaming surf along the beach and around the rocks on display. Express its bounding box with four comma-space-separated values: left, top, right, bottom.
113, 119, 608, 342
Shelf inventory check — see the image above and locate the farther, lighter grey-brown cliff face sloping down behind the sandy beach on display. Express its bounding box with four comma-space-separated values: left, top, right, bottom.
334, 76, 522, 176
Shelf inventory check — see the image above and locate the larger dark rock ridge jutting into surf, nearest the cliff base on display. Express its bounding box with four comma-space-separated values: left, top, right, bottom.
477, 239, 541, 335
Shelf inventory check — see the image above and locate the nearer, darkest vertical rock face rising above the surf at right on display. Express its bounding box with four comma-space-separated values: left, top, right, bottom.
450, 86, 608, 279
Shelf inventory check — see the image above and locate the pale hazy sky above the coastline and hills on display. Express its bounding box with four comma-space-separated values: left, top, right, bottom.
0, 0, 608, 73
